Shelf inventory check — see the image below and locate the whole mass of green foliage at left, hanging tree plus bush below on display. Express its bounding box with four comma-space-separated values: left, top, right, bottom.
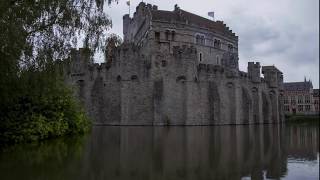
0, 0, 117, 143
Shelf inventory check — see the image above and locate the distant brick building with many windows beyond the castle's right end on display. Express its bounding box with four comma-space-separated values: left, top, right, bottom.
283, 79, 319, 114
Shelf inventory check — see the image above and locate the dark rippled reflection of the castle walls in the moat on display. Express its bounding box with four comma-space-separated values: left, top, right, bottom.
82, 126, 319, 179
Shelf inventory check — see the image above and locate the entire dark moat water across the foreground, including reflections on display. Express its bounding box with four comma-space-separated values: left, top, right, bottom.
0, 125, 319, 180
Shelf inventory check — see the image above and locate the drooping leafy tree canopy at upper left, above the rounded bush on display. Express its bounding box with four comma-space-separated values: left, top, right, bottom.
0, 0, 118, 103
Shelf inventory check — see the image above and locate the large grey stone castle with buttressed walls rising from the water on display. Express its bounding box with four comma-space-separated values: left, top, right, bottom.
65, 2, 284, 125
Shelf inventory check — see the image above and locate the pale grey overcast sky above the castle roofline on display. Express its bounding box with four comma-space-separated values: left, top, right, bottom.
101, 0, 319, 88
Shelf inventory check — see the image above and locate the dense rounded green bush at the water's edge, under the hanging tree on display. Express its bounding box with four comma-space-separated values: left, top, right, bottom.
0, 67, 90, 144
